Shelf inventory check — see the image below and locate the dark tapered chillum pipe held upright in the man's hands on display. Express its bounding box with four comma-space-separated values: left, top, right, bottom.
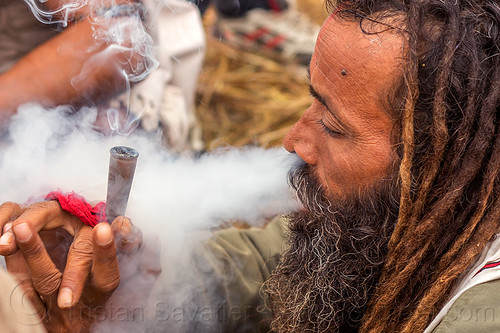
106, 146, 139, 223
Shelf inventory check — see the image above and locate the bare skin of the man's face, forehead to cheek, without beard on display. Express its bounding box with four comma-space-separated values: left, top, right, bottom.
284, 16, 403, 198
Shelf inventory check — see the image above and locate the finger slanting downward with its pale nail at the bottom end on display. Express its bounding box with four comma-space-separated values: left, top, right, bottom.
57, 226, 94, 309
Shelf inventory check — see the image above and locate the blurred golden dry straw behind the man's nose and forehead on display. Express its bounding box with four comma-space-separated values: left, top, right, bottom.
193, 0, 322, 150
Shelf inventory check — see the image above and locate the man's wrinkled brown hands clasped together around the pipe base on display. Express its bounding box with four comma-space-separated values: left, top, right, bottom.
0, 201, 160, 332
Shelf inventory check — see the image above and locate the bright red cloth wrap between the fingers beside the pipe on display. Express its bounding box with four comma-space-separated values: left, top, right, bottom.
45, 191, 107, 227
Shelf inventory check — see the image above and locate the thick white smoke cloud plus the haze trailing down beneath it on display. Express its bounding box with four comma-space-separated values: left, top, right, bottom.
0, 105, 297, 332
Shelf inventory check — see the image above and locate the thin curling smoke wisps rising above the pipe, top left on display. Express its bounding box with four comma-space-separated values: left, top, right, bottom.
24, 0, 160, 134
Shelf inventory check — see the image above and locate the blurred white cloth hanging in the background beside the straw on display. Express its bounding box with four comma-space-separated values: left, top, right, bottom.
118, 0, 206, 152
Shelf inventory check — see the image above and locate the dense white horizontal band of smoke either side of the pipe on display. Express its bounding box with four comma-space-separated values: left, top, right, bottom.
0, 105, 296, 231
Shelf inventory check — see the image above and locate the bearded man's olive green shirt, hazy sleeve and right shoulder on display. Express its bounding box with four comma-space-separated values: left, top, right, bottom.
146, 217, 500, 333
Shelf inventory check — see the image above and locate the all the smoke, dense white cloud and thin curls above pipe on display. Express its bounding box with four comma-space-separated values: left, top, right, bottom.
9, 0, 301, 332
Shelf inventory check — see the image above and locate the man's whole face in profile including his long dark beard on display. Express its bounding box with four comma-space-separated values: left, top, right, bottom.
266, 17, 402, 332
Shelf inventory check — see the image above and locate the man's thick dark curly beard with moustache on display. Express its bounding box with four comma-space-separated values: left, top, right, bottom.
265, 166, 399, 332
